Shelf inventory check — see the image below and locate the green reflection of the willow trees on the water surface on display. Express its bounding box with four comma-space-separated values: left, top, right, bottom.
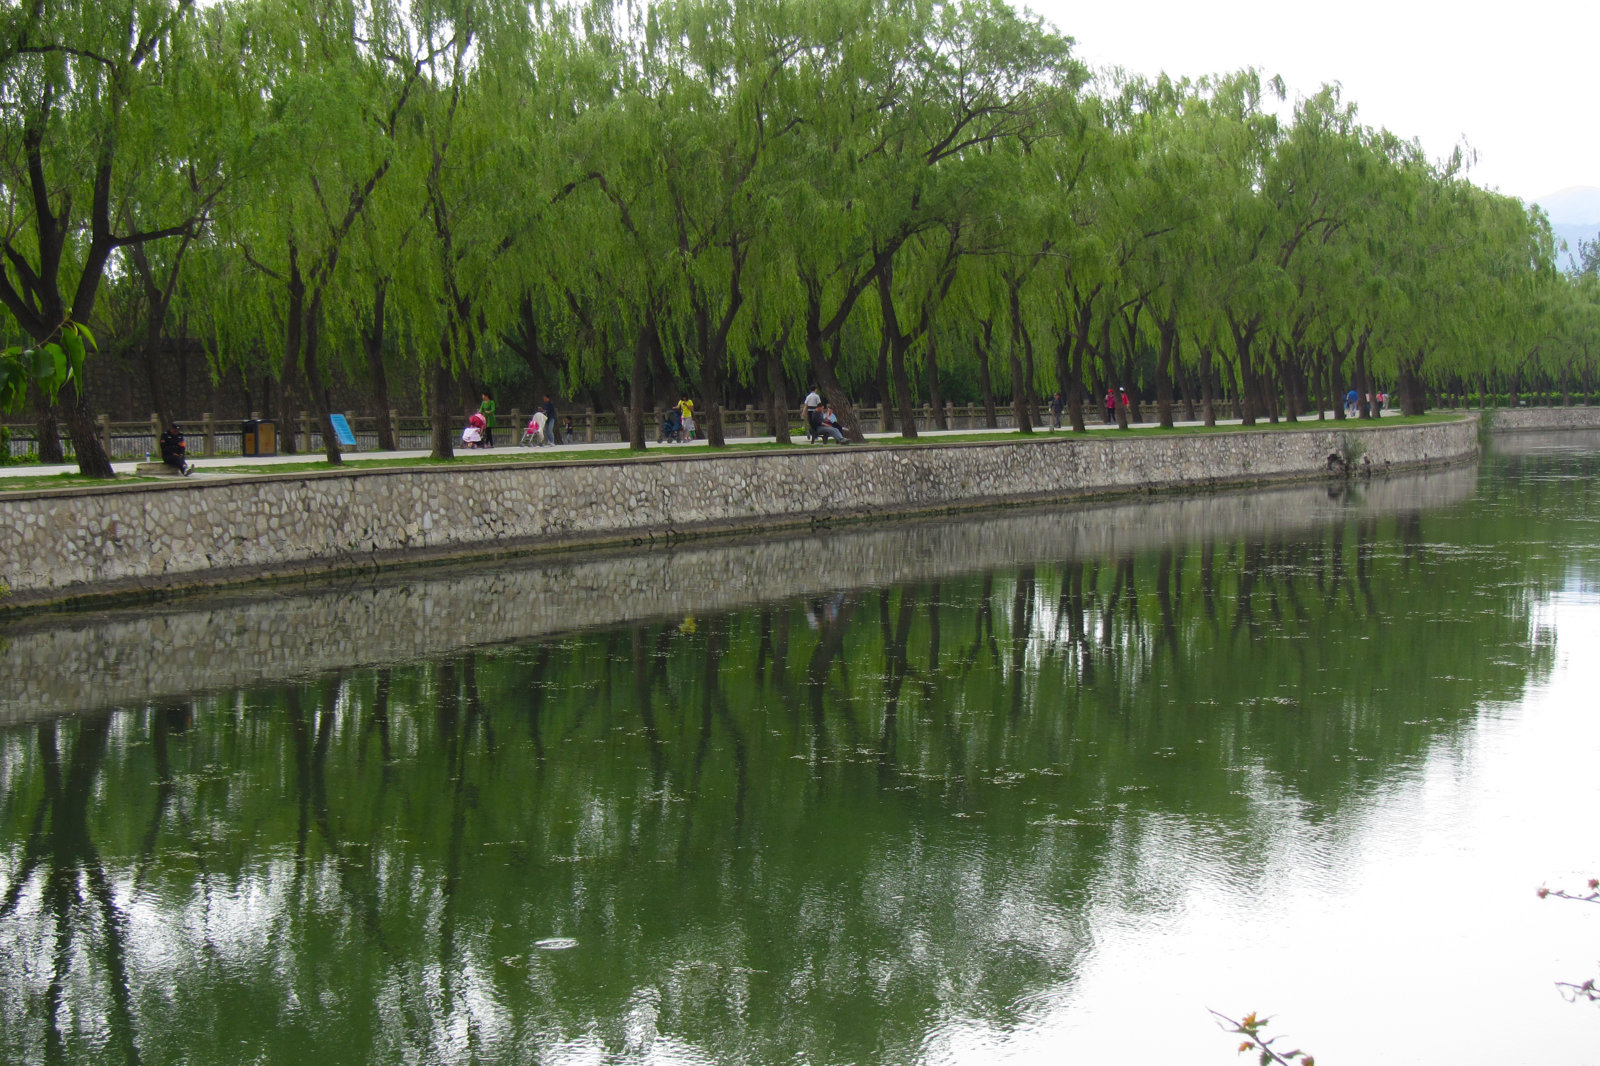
0, 442, 1600, 1063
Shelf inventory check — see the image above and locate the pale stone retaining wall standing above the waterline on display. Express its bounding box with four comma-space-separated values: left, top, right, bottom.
0, 419, 1477, 610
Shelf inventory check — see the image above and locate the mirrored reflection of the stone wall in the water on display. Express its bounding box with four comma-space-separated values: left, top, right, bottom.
0, 466, 1477, 723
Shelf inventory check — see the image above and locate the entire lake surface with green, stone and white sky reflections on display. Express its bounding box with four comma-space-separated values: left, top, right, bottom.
0, 434, 1600, 1066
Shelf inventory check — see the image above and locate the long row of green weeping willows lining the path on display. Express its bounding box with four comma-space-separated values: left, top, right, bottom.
0, 0, 1600, 475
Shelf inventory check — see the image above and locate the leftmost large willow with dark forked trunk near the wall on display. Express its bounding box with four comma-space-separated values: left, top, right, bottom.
0, 0, 227, 477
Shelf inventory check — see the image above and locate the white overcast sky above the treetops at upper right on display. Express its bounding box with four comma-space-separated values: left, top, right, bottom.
1013, 0, 1600, 209
